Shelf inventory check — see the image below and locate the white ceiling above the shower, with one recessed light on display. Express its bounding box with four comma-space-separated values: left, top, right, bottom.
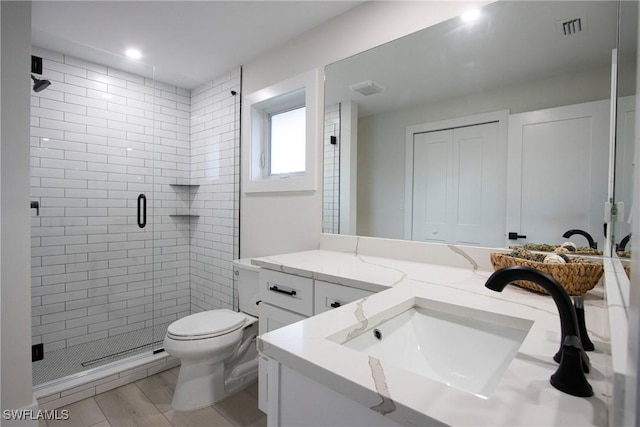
32, 0, 364, 89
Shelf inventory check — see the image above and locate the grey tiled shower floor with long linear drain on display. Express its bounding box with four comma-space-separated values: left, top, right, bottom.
32, 323, 170, 386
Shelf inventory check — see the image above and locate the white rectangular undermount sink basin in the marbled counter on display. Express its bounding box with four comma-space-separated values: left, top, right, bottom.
338, 298, 533, 397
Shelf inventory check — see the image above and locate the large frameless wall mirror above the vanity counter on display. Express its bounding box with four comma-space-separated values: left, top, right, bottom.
323, 1, 637, 254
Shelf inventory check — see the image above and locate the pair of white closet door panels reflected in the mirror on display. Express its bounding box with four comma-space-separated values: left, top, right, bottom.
412, 122, 504, 246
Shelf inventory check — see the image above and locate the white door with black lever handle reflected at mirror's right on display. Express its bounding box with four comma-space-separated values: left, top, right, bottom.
507, 100, 609, 247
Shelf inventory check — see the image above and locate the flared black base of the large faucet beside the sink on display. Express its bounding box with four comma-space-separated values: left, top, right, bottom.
550, 335, 593, 397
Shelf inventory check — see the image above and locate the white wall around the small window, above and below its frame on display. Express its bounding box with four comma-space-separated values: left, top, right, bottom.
240, 1, 490, 258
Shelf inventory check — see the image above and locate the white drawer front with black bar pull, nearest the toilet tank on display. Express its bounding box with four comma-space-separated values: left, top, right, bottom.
259, 269, 313, 316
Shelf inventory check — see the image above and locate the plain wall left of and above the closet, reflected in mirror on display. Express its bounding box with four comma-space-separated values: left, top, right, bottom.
357, 67, 611, 239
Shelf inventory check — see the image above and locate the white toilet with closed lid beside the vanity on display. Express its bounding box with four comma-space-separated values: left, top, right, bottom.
164, 259, 259, 411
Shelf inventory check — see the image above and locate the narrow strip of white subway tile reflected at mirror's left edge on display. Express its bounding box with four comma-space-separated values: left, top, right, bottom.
322, 104, 340, 234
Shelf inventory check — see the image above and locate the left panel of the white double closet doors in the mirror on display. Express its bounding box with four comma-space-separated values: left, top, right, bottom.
412, 130, 453, 242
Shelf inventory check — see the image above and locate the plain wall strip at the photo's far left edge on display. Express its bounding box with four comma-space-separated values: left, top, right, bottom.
0, 2, 34, 425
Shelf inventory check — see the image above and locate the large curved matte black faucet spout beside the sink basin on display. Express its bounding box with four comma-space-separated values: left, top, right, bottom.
485, 266, 593, 397
